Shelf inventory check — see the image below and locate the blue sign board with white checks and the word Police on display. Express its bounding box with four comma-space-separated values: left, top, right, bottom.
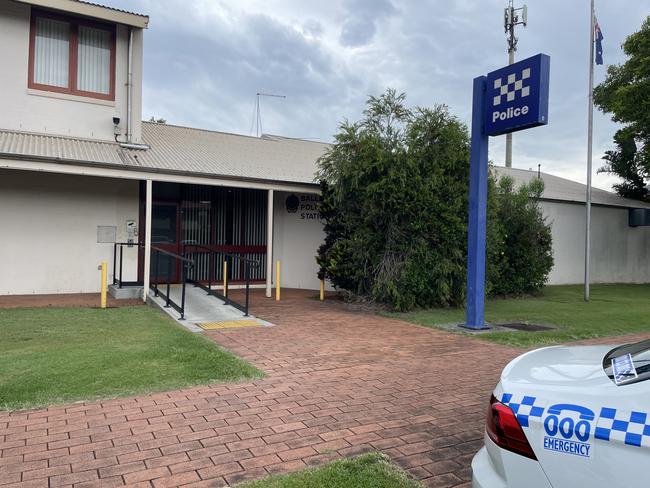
485, 54, 551, 136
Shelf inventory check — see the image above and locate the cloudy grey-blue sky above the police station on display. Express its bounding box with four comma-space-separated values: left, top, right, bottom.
104, 0, 650, 188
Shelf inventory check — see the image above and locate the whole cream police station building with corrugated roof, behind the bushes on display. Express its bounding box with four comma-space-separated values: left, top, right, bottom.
0, 0, 650, 304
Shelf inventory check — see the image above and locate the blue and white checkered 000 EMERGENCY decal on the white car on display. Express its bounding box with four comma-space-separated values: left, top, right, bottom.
501, 393, 650, 458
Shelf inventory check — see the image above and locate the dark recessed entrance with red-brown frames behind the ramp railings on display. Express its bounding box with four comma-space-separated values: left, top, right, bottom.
141, 182, 267, 283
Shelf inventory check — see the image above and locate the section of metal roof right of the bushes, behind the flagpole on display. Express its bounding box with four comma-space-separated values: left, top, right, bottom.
493, 166, 650, 208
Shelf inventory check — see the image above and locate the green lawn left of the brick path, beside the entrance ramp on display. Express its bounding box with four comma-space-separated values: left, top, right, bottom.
0, 306, 262, 410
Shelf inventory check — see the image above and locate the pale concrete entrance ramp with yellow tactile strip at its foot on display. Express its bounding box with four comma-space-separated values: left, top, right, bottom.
149, 284, 273, 332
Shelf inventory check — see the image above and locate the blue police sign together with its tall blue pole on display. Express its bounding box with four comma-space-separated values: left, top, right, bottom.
465, 54, 551, 330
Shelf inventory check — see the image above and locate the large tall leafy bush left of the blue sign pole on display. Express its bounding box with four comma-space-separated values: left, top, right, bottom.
317, 90, 469, 310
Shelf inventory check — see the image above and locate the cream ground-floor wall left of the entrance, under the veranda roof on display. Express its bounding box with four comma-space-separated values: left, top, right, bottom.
0, 170, 139, 295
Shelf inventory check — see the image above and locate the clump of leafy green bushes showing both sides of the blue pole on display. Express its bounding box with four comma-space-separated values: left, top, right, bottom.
317, 90, 553, 310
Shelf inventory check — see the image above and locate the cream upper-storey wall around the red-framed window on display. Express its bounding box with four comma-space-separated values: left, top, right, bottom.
0, 0, 142, 142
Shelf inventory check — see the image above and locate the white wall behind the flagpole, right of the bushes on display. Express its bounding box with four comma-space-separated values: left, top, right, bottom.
541, 201, 650, 285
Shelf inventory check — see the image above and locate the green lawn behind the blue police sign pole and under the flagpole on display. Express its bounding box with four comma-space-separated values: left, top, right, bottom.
391, 285, 650, 347
